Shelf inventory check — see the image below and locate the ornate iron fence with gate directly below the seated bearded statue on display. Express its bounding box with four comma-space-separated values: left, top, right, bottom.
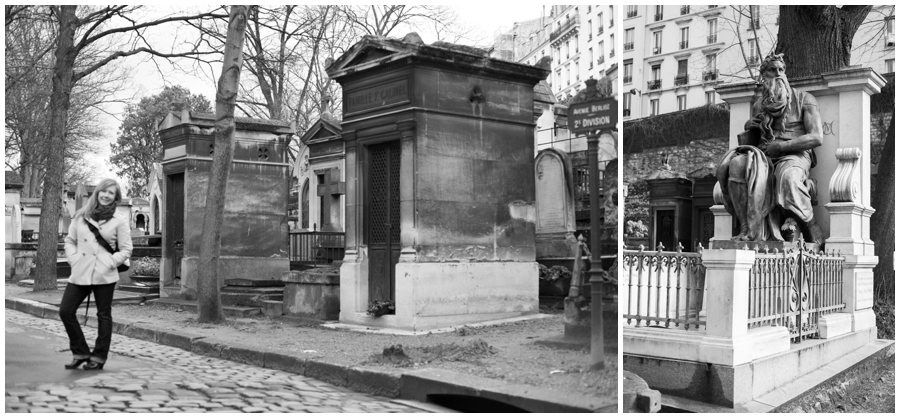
747, 242, 844, 342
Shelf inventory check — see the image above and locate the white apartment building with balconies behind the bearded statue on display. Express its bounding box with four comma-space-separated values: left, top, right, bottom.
621, 5, 894, 120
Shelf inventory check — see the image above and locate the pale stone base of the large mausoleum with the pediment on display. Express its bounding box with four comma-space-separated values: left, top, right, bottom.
340, 260, 538, 331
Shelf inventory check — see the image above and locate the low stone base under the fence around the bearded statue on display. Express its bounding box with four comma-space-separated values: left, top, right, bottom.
622, 328, 876, 408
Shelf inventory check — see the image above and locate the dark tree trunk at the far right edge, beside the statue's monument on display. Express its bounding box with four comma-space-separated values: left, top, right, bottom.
870, 110, 897, 300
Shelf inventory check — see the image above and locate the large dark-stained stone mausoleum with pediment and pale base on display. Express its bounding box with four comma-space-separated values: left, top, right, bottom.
327, 34, 548, 330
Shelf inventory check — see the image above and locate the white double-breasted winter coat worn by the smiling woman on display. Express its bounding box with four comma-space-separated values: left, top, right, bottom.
66, 213, 132, 285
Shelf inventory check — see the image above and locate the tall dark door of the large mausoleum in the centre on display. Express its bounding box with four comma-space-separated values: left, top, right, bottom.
366, 141, 400, 302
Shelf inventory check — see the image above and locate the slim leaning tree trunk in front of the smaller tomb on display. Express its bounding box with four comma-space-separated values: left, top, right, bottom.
197, 6, 249, 322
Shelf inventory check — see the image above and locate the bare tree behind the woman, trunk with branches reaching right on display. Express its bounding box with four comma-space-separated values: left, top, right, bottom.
26, 5, 227, 291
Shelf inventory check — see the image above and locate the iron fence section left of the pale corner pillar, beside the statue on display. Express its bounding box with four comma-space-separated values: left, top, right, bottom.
622, 244, 706, 330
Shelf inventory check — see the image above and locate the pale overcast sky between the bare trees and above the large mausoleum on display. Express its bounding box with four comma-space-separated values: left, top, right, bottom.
93, 2, 542, 186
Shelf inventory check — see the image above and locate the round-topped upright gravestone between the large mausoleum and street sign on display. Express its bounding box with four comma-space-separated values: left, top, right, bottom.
534, 148, 577, 260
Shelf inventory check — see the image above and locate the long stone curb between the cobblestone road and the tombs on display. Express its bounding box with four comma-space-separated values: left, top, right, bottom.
6, 298, 617, 412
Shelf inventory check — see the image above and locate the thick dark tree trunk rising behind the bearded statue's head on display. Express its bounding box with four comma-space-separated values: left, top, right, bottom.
763, 6, 872, 79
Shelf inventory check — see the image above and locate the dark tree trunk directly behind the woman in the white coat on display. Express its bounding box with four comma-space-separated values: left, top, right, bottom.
33, 6, 77, 292
